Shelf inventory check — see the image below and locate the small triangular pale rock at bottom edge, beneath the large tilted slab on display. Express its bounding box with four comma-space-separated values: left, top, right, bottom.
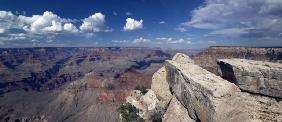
162, 97, 195, 122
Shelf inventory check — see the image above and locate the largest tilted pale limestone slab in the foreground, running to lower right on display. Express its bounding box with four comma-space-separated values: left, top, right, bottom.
156, 54, 282, 122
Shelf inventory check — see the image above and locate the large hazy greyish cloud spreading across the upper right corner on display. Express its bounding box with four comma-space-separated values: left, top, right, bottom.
180, 0, 282, 38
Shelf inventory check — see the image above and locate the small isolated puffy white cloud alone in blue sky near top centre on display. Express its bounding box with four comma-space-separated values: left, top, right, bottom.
123, 18, 143, 31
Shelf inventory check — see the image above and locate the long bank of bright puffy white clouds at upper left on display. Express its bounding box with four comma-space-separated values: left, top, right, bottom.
0, 11, 112, 34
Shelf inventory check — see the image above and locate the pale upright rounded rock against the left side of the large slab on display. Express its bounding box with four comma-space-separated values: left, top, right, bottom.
151, 67, 172, 107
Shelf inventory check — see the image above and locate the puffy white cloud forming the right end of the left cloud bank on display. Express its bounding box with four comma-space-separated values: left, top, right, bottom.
79, 13, 106, 32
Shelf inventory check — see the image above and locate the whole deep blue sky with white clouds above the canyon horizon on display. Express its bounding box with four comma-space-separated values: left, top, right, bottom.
0, 0, 282, 48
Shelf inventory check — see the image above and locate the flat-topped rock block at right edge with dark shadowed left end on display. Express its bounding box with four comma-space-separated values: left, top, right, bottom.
218, 59, 282, 98
